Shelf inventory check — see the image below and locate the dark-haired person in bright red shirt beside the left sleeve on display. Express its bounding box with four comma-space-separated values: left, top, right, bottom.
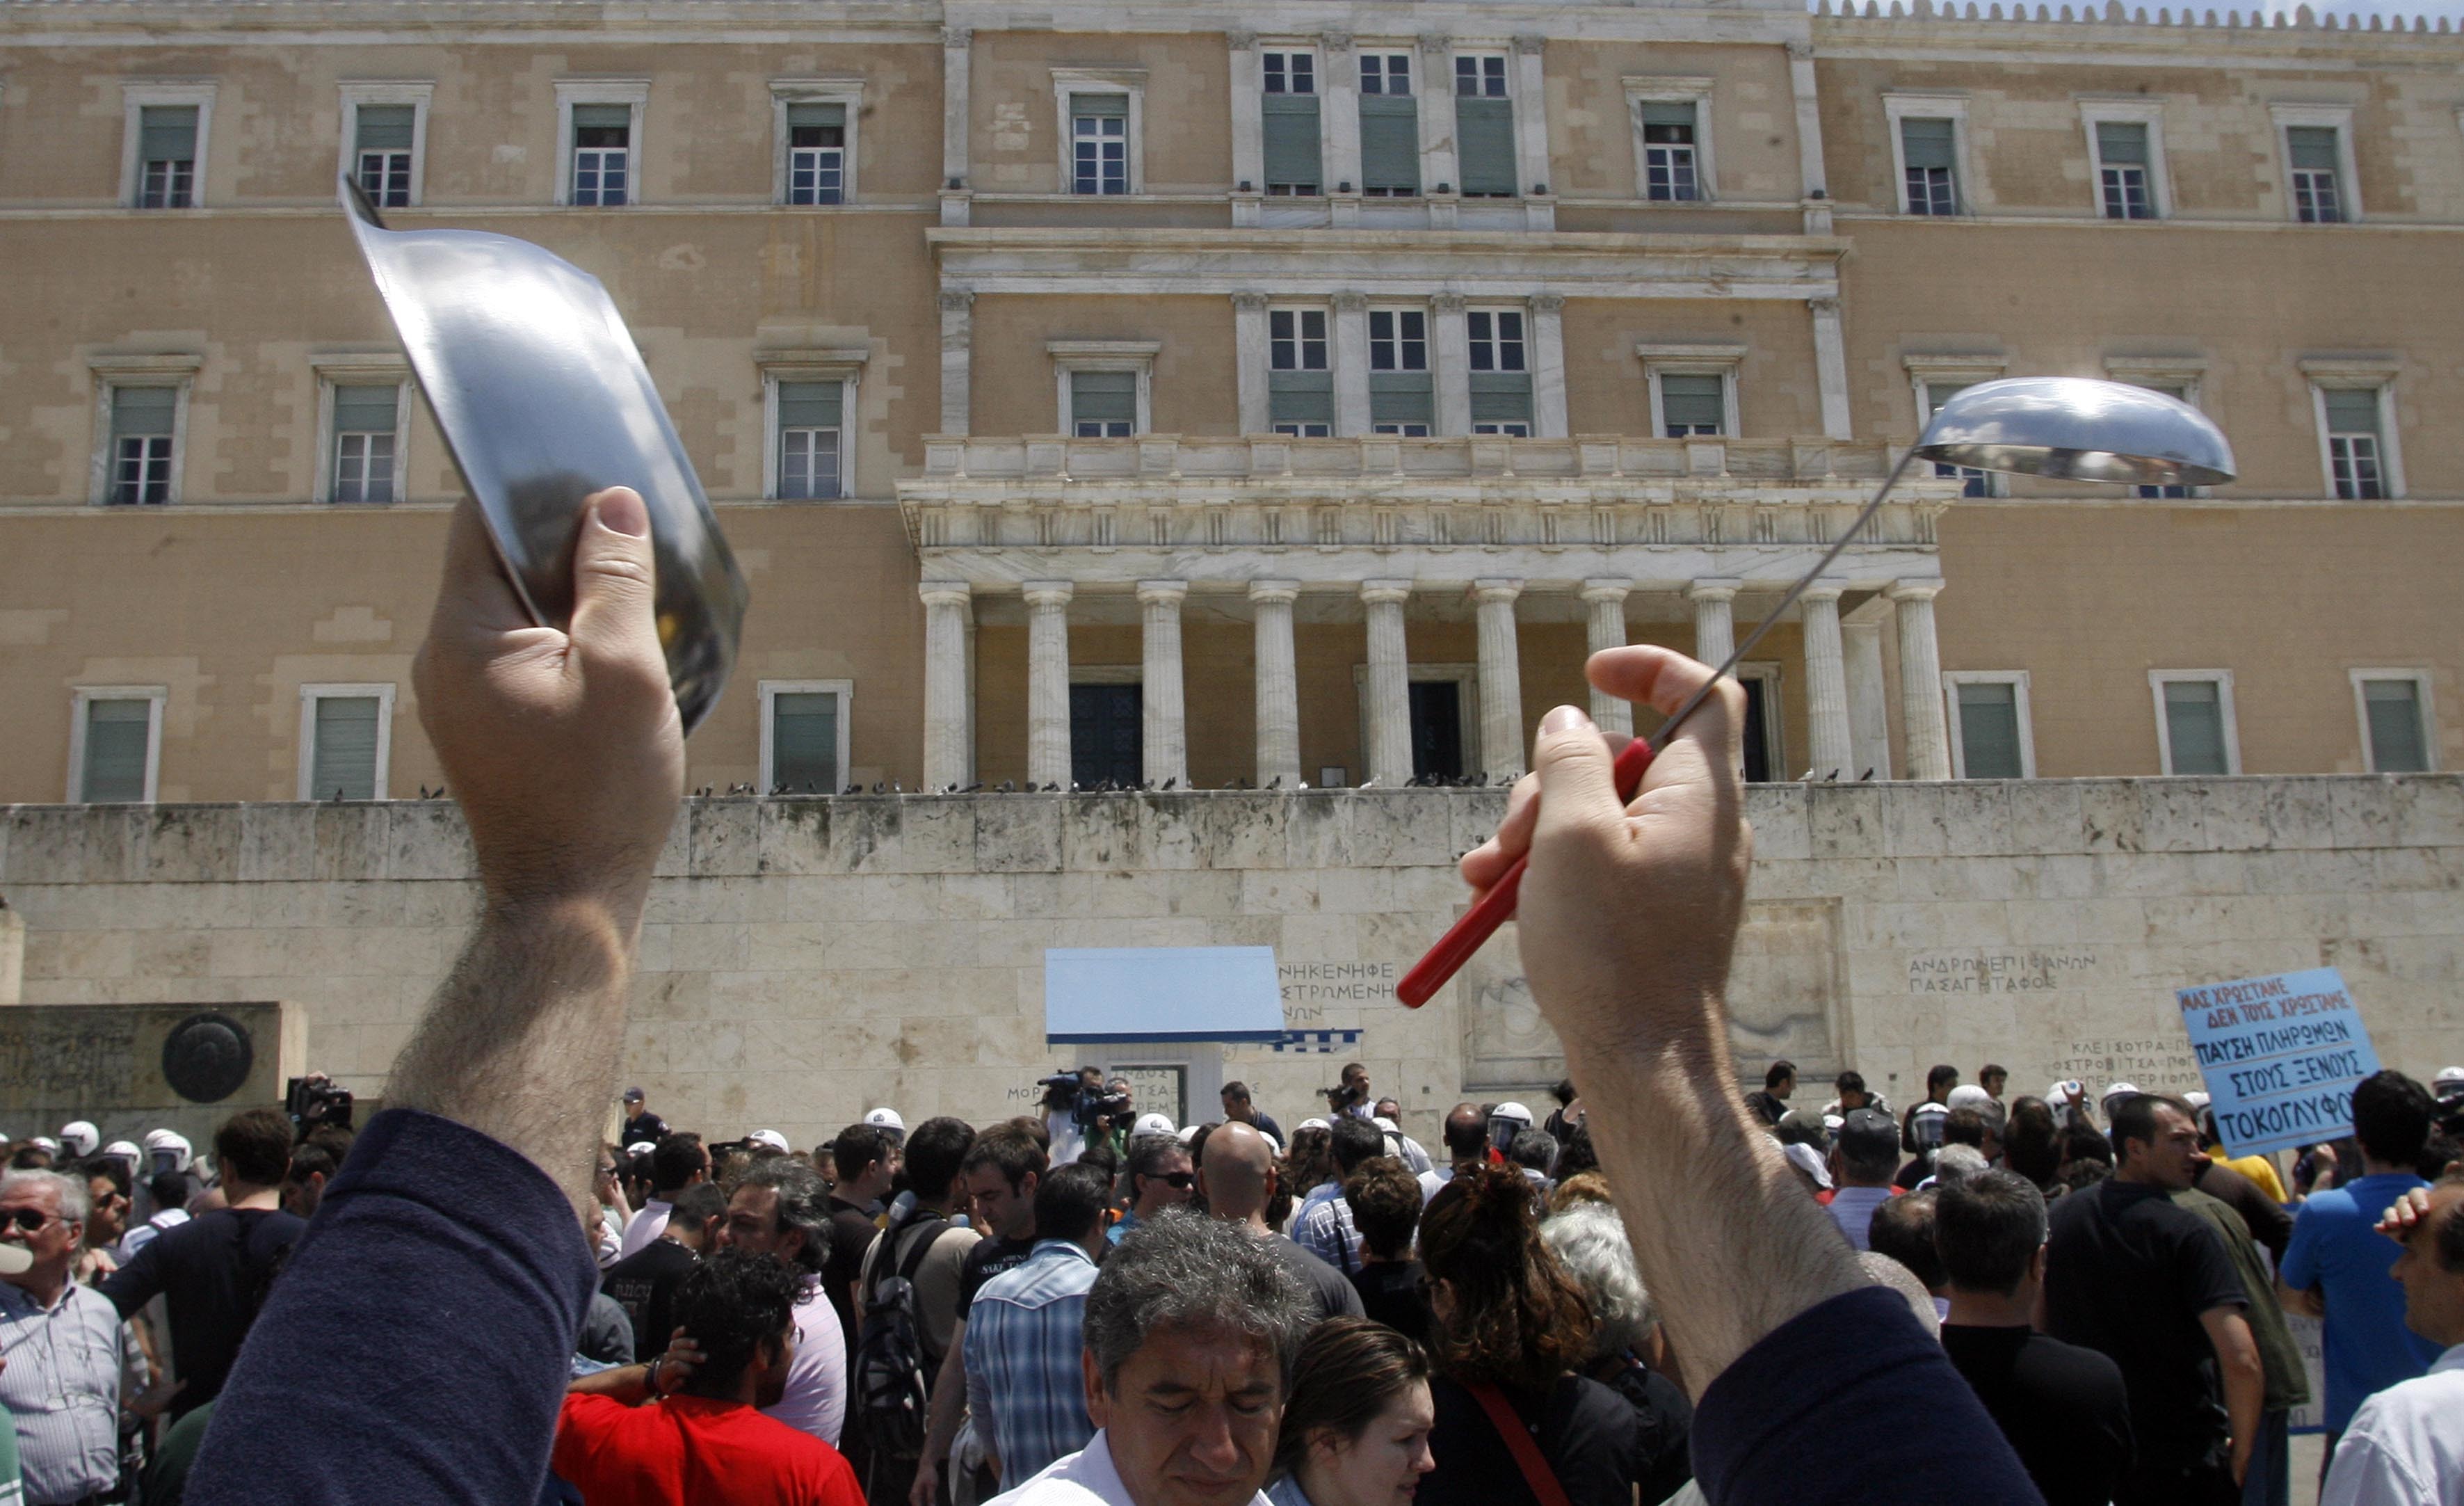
552, 1249, 865, 1506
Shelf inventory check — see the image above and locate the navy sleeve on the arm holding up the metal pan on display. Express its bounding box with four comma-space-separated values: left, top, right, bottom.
187, 1110, 599, 1506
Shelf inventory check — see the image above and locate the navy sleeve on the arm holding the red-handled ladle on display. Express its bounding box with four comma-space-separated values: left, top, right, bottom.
1693, 1287, 2043, 1506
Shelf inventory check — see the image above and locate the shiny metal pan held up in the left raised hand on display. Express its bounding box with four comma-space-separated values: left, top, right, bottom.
342, 175, 749, 732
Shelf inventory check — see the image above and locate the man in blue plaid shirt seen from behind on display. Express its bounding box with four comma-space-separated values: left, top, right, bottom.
966, 1166, 1111, 1491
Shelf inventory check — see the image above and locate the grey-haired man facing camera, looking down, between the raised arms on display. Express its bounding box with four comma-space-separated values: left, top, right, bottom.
995, 1212, 1316, 1506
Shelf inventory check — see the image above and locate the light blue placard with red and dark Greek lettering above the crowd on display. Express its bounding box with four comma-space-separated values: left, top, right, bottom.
2173, 966, 2378, 1156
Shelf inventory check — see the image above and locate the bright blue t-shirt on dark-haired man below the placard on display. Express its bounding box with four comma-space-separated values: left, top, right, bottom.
2279, 1171, 2440, 1432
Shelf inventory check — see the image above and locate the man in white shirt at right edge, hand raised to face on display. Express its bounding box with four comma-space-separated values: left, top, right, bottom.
2319, 1176, 2464, 1506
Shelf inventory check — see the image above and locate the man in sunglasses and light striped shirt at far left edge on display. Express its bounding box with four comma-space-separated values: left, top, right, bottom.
0, 1171, 143, 1506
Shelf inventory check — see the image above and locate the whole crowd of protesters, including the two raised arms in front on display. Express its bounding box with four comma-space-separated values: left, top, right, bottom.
0, 488, 2464, 1506
